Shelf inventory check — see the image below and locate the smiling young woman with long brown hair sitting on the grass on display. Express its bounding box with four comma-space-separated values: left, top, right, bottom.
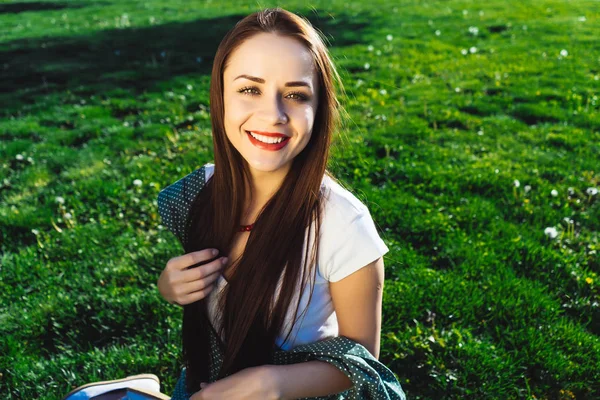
63, 8, 405, 400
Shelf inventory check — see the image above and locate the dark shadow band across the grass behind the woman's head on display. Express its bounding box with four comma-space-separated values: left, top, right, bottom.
0, 9, 373, 116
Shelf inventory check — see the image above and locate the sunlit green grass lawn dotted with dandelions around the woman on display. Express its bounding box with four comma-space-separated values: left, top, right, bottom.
0, 0, 600, 399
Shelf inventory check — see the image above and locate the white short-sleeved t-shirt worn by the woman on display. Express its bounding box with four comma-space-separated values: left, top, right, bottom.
199, 163, 389, 351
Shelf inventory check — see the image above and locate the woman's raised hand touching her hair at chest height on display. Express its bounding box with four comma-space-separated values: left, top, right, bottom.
157, 249, 227, 306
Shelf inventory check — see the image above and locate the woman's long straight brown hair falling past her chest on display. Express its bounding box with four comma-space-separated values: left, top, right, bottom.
183, 7, 344, 393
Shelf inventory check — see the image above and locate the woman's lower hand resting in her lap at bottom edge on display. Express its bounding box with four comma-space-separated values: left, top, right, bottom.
190, 365, 279, 400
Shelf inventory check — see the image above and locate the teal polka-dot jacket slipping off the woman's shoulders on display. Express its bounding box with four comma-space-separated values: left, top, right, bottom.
157, 167, 406, 400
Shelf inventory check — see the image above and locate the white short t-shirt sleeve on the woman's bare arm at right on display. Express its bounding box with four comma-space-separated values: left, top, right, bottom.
325, 207, 389, 282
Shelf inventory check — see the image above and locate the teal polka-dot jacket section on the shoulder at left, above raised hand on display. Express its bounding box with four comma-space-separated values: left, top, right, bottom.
157, 166, 206, 244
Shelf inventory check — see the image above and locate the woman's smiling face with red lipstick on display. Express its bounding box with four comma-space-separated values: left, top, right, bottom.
223, 33, 319, 177
